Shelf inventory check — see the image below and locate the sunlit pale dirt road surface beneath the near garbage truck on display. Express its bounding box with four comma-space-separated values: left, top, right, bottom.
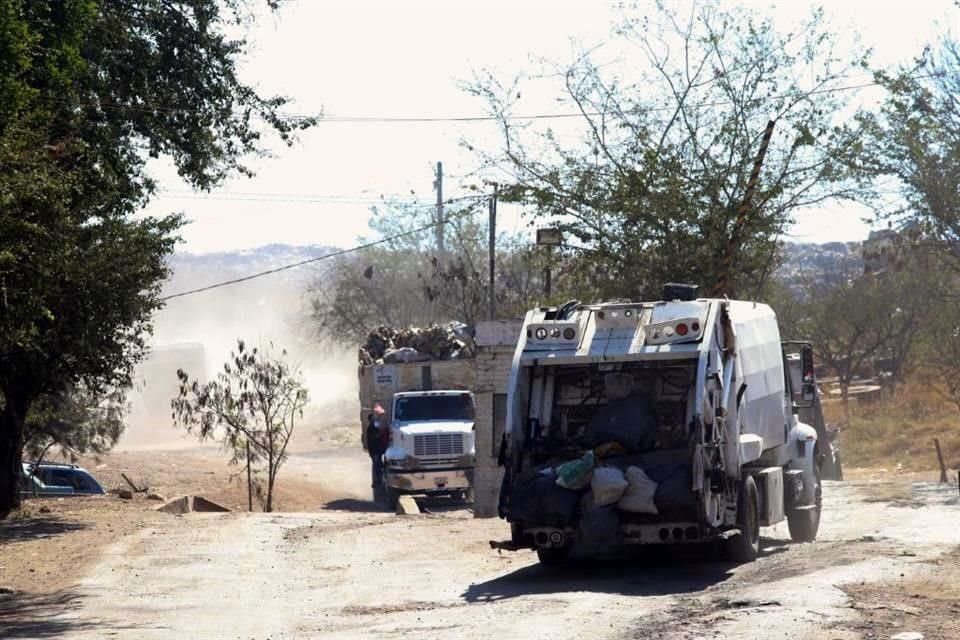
0, 459, 960, 640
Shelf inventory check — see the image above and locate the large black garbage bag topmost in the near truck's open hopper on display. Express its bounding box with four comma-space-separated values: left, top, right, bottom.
583, 395, 657, 453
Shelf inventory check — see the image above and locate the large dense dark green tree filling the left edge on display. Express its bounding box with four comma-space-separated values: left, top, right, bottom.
0, 0, 314, 517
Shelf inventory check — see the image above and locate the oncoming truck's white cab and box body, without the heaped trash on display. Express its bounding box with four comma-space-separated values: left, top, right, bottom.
359, 359, 476, 509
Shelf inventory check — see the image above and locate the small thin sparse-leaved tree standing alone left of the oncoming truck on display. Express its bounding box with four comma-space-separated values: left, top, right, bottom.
170, 340, 308, 511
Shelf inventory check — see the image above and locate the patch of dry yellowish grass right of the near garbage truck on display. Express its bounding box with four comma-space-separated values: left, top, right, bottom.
824, 380, 960, 471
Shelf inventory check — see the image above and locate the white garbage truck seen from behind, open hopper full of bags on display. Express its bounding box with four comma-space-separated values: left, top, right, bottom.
491, 284, 821, 564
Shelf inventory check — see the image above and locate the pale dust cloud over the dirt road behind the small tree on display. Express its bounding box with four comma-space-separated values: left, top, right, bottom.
117, 254, 359, 451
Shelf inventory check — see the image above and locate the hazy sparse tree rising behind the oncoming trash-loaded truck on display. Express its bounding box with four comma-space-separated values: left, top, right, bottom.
308, 198, 542, 344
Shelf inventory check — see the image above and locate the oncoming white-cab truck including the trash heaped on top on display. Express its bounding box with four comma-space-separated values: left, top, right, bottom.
358, 325, 476, 508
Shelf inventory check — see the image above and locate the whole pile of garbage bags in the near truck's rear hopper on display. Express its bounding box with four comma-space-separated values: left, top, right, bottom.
505, 395, 696, 554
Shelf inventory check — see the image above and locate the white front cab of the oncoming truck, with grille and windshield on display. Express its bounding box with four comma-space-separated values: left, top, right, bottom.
384, 390, 476, 507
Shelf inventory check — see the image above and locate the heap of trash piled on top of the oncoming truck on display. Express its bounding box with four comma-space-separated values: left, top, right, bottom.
359, 322, 475, 365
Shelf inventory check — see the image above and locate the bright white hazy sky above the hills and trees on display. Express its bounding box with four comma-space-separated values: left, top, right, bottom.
139, 0, 960, 253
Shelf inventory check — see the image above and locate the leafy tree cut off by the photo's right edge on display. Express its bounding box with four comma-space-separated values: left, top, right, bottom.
865, 31, 960, 407
